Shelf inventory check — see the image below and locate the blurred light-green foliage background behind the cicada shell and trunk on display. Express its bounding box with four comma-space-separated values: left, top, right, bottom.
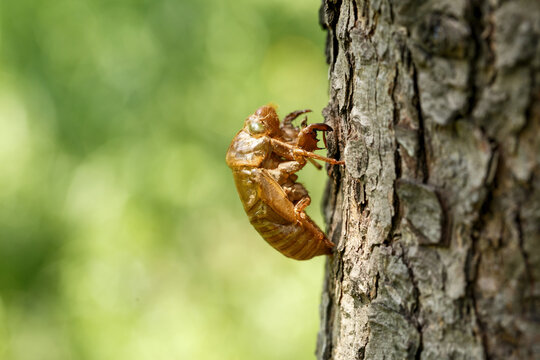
0, 0, 327, 360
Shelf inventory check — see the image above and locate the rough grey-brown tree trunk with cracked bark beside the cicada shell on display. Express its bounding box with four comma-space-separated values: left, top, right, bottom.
317, 0, 540, 360
